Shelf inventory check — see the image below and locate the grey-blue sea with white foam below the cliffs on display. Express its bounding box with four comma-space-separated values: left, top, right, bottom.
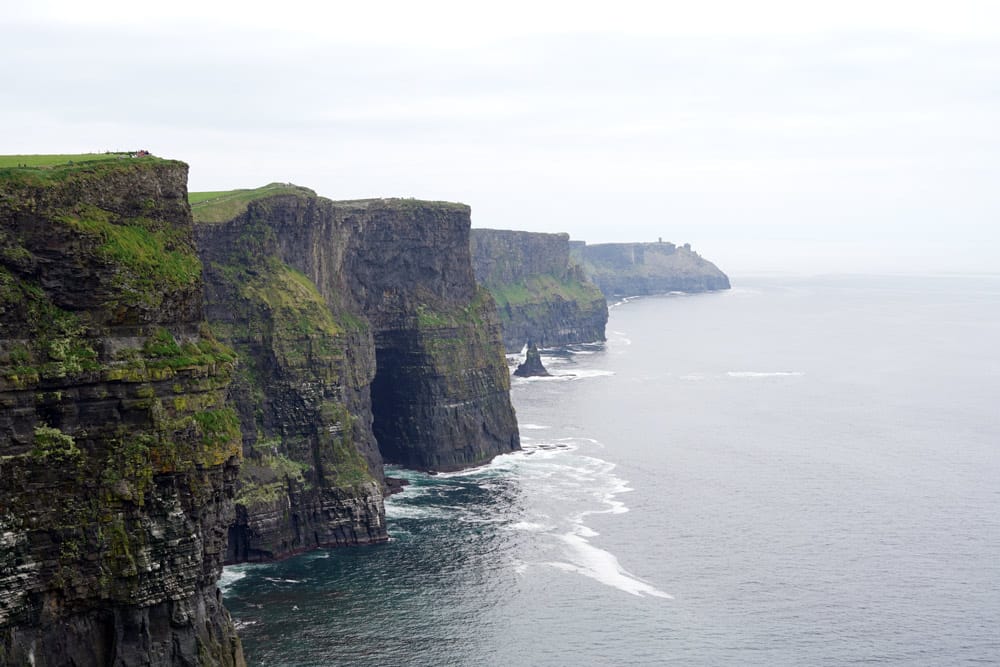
222, 276, 1000, 666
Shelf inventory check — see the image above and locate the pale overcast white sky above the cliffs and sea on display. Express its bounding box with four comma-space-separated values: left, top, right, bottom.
0, 0, 1000, 275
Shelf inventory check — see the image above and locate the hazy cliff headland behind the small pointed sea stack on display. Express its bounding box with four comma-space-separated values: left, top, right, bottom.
472, 229, 608, 352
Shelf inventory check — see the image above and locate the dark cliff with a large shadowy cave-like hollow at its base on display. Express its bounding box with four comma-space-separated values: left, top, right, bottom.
338, 200, 520, 470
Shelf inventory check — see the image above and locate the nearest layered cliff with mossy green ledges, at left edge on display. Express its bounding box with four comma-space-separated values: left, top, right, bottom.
0, 159, 243, 666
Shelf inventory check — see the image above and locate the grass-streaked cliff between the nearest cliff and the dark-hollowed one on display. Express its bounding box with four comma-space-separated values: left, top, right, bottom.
197, 193, 387, 562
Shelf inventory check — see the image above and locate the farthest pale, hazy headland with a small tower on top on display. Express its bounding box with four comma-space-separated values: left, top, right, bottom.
573, 242, 729, 299
